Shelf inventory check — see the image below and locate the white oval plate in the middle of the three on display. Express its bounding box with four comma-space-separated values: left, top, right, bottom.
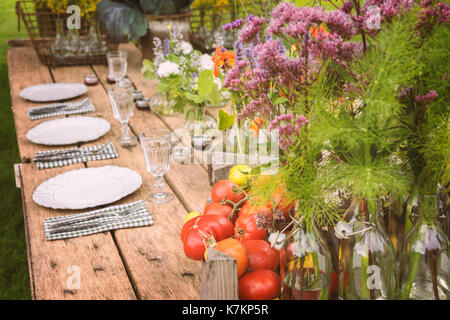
27, 116, 111, 146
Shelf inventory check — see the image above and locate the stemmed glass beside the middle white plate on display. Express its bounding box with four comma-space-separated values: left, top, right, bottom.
108, 79, 137, 147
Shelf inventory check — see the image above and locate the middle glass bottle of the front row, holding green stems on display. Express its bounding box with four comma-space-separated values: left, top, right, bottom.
339, 198, 395, 300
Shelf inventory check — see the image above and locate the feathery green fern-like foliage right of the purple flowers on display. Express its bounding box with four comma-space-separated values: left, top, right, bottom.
251, 6, 450, 226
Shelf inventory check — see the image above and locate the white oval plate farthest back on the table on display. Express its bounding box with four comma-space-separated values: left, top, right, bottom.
19, 82, 87, 102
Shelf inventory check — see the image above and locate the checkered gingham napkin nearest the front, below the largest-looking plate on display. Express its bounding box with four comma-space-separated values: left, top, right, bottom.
44, 200, 153, 241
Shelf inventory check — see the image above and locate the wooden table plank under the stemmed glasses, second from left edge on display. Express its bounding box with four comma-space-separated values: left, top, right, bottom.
52, 66, 201, 299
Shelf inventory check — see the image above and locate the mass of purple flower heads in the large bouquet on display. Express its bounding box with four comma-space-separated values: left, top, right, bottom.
224, 0, 422, 149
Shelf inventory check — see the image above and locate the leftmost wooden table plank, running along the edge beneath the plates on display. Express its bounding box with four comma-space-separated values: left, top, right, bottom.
8, 48, 136, 299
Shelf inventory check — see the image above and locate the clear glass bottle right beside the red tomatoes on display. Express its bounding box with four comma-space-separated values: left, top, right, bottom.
280, 218, 331, 300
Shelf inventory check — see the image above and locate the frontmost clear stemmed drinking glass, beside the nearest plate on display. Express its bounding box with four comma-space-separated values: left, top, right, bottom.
139, 130, 173, 203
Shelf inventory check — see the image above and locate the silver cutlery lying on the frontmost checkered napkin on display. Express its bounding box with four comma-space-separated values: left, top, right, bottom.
49, 202, 144, 233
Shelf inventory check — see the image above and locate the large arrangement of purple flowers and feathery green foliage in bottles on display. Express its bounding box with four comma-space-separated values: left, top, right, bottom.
213, 0, 450, 299
